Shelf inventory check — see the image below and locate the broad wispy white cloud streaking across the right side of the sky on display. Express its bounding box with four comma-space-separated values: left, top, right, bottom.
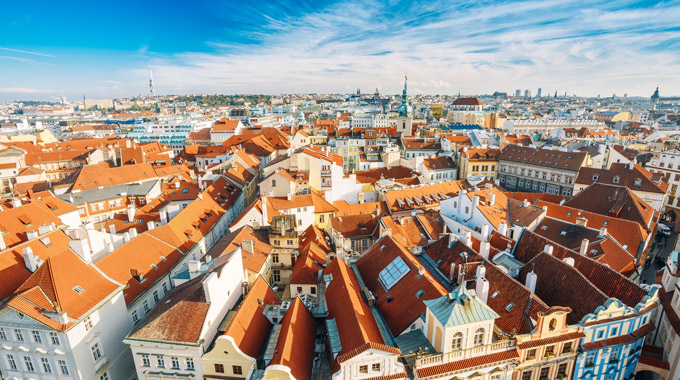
135, 0, 680, 95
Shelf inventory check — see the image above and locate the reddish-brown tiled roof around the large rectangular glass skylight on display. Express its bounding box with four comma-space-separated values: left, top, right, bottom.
356, 236, 448, 335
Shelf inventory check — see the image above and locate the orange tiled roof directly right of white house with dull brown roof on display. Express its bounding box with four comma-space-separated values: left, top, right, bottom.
224, 276, 280, 358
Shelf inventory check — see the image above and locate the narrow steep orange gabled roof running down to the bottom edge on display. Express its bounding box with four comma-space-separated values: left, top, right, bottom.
269, 298, 316, 380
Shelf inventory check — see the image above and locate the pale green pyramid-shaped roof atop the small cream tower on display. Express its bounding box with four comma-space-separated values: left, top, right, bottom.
423, 285, 500, 327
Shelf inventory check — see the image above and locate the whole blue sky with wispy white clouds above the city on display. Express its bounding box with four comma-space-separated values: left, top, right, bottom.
0, 0, 680, 101
